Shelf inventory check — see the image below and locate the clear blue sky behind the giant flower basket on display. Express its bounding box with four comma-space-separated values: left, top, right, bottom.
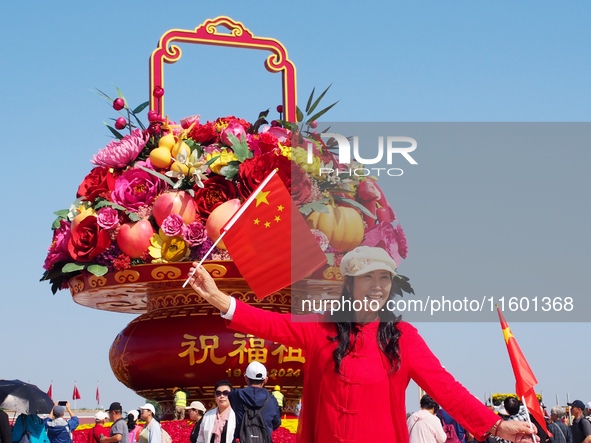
0, 0, 591, 409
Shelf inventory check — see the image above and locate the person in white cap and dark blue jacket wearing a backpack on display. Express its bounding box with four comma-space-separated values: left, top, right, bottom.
229, 361, 281, 438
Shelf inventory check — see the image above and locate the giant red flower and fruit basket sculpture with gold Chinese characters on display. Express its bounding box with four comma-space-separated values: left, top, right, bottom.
42, 17, 406, 413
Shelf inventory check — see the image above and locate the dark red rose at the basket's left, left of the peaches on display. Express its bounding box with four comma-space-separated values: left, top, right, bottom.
68, 215, 111, 263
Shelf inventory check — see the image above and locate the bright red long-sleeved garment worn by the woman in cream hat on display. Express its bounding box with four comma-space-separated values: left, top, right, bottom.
229, 300, 498, 443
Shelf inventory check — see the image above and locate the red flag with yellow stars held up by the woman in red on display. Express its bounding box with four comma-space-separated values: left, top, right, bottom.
222, 170, 326, 299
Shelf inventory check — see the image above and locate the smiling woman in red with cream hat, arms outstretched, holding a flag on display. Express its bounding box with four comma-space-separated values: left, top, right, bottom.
189, 246, 533, 443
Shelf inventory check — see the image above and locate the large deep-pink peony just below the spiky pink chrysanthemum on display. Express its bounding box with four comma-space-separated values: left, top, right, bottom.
111, 169, 166, 212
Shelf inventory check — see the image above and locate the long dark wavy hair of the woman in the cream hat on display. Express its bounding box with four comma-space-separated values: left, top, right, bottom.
328, 275, 414, 374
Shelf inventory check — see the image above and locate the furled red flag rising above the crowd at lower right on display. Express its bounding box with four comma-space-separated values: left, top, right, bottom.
497, 308, 549, 434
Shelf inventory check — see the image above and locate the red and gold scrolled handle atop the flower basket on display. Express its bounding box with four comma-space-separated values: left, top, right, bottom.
150, 16, 296, 122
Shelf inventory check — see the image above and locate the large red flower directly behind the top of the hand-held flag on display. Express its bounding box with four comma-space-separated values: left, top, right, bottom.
238, 152, 291, 199
